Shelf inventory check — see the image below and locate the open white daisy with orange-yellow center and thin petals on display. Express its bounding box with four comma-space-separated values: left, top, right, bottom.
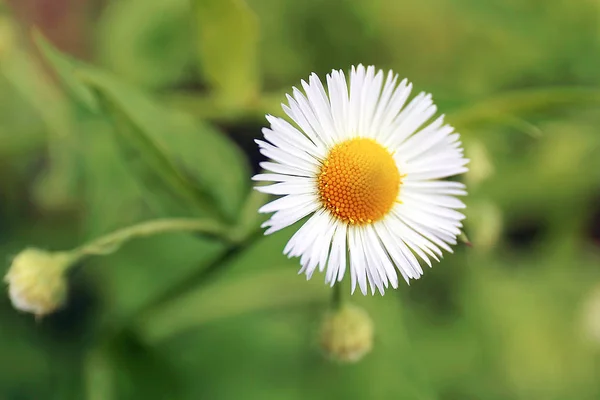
253, 65, 468, 294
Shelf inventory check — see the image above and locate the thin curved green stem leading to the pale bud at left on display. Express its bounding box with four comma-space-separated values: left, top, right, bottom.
73, 218, 237, 258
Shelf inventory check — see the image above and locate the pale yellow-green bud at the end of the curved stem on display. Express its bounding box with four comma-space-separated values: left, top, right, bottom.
4, 248, 73, 316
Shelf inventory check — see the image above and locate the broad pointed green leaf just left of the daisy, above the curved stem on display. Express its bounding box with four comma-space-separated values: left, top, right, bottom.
36, 35, 249, 221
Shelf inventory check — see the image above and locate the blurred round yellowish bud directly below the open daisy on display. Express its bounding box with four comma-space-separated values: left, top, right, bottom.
321, 305, 373, 363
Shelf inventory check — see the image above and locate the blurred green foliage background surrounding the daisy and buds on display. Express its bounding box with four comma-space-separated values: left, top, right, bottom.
0, 0, 600, 400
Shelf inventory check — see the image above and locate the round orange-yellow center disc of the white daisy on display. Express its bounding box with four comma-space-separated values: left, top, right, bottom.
318, 138, 402, 224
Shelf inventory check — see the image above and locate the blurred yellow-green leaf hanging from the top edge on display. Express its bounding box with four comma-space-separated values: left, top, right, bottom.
192, 0, 259, 104
